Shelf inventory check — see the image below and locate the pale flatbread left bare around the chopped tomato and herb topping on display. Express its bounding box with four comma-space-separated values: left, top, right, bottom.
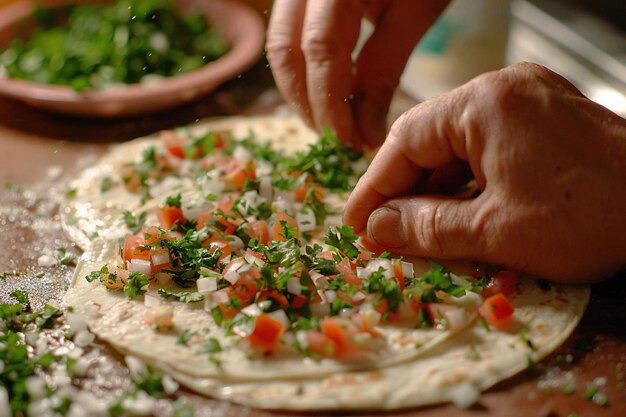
62, 116, 589, 410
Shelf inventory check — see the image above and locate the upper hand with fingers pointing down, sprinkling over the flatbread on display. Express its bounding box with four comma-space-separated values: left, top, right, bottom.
266, 0, 449, 149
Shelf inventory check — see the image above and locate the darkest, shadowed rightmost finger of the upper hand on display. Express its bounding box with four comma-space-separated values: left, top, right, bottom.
353, 1, 448, 147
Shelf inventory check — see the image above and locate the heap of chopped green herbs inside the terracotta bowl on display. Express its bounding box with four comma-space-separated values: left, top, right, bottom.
0, 0, 229, 91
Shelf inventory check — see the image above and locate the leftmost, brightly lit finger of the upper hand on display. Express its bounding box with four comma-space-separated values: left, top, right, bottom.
266, 0, 314, 126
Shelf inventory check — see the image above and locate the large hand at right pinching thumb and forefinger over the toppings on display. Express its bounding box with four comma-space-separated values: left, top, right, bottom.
344, 64, 626, 282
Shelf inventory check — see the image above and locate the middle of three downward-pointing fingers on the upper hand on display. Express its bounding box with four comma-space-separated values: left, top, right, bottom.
302, 0, 362, 143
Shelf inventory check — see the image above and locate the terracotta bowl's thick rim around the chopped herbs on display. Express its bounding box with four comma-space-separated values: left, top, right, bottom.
0, 0, 265, 118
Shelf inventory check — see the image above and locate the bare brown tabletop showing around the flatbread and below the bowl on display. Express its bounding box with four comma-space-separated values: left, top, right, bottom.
0, 64, 626, 417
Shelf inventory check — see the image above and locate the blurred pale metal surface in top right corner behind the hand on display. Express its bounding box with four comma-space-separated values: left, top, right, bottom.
507, 0, 626, 116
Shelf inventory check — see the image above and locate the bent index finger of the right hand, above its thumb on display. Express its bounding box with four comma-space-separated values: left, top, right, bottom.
344, 90, 472, 232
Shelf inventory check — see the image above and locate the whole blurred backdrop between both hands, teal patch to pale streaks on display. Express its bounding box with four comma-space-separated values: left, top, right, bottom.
402, 0, 626, 116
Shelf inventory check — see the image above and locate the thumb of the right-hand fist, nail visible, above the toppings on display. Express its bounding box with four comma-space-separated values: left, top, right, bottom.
367, 197, 484, 259
